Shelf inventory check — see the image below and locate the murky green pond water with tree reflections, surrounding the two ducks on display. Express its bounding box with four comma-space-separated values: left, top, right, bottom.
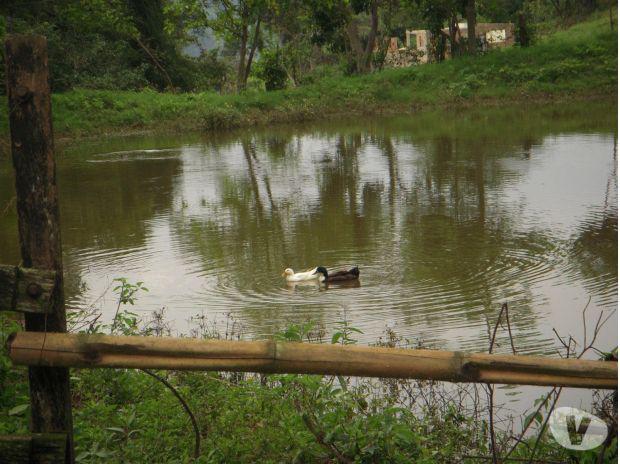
0, 102, 618, 364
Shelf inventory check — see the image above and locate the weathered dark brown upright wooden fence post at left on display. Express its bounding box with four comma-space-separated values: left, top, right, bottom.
5, 35, 74, 463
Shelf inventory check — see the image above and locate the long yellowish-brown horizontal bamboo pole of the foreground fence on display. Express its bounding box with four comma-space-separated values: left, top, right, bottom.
8, 332, 618, 389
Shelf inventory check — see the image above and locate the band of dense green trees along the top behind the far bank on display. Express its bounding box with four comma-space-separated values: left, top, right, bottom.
0, 0, 610, 92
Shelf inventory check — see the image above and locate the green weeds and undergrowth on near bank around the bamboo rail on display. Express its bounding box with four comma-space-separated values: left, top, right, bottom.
0, 296, 617, 463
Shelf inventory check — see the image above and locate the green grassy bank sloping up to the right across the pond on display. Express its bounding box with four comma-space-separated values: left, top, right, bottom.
0, 12, 617, 140
